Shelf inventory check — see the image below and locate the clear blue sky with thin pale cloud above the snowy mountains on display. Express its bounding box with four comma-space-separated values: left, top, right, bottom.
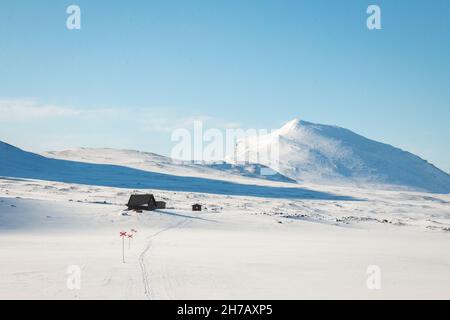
0, 0, 450, 172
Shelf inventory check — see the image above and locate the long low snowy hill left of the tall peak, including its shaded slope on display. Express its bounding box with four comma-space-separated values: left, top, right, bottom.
0, 141, 298, 197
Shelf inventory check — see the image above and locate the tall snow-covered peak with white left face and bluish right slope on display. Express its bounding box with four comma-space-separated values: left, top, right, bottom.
228, 119, 450, 193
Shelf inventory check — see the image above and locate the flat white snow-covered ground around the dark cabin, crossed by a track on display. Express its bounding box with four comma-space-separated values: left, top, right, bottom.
0, 178, 450, 299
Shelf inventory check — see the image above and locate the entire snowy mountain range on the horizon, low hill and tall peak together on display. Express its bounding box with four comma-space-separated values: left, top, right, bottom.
0, 119, 450, 193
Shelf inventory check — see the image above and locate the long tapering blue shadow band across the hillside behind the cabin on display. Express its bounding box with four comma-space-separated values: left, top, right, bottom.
0, 153, 357, 200
